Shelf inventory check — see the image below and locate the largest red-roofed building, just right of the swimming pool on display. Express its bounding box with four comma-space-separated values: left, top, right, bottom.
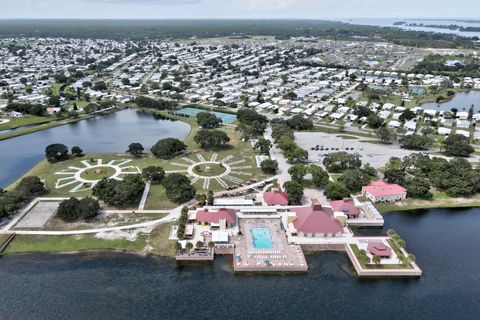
289, 205, 343, 238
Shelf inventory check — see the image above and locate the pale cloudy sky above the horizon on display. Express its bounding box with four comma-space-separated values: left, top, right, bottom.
0, 0, 480, 19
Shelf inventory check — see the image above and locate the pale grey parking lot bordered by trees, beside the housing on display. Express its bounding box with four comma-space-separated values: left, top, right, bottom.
295, 132, 414, 168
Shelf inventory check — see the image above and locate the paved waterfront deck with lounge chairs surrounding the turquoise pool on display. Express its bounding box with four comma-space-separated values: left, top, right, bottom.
233, 218, 308, 272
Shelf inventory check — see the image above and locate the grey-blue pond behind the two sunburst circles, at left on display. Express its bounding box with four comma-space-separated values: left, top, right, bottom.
0, 109, 190, 187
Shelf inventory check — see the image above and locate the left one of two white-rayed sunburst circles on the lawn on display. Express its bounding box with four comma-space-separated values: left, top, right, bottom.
55, 159, 142, 192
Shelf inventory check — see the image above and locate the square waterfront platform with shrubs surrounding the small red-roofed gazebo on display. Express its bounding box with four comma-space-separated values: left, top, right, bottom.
345, 237, 422, 277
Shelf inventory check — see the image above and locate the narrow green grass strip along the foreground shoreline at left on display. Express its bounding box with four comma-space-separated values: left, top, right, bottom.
5, 235, 147, 254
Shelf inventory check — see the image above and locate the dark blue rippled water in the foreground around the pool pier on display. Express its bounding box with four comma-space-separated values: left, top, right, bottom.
0, 209, 480, 320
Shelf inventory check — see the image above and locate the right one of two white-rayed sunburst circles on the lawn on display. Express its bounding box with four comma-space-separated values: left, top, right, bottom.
167, 153, 252, 190
